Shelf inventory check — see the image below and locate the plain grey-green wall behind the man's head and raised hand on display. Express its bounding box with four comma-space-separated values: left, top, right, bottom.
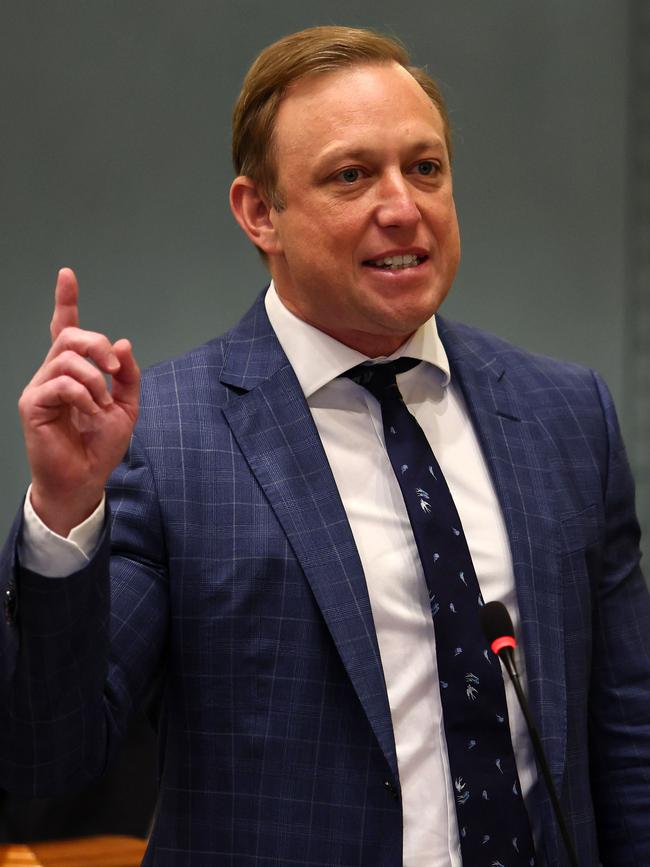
0, 0, 644, 556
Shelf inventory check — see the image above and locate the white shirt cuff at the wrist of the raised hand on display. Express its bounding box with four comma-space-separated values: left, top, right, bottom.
18, 485, 106, 578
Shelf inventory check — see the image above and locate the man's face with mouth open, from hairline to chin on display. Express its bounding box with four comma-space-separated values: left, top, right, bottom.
268, 64, 460, 357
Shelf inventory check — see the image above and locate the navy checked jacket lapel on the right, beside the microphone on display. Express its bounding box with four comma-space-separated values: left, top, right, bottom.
438, 319, 566, 786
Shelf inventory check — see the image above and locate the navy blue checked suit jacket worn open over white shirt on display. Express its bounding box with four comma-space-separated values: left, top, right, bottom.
0, 299, 650, 867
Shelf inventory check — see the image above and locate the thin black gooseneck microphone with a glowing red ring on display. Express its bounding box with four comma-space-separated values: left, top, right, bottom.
480, 602, 579, 867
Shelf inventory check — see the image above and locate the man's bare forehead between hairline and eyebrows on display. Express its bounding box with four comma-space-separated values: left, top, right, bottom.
274, 62, 444, 163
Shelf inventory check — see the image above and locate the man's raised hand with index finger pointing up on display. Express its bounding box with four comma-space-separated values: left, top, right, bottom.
18, 268, 140, 536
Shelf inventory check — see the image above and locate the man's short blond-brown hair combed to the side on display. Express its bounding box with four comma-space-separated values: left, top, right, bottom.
232, 26, 451, 209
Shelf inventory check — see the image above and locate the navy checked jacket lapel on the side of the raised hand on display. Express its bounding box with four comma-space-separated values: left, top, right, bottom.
221, 300, 398, 780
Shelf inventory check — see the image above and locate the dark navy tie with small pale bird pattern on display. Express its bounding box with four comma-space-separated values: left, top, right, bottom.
344, 358, 535, 867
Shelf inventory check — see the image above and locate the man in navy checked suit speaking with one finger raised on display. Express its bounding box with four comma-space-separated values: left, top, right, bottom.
0, 28, 650, 867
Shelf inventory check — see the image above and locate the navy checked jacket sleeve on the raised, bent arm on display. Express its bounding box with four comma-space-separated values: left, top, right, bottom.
0, 438, 168, 797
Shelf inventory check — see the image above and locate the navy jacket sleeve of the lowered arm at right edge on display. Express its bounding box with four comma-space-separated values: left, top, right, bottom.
584, 377, 650, 867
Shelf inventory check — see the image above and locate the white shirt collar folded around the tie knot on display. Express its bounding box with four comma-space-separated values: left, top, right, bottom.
264, 281, 450, 398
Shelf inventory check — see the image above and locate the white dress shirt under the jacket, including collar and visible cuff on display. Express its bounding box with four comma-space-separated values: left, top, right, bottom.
19, 284, 538, 867
